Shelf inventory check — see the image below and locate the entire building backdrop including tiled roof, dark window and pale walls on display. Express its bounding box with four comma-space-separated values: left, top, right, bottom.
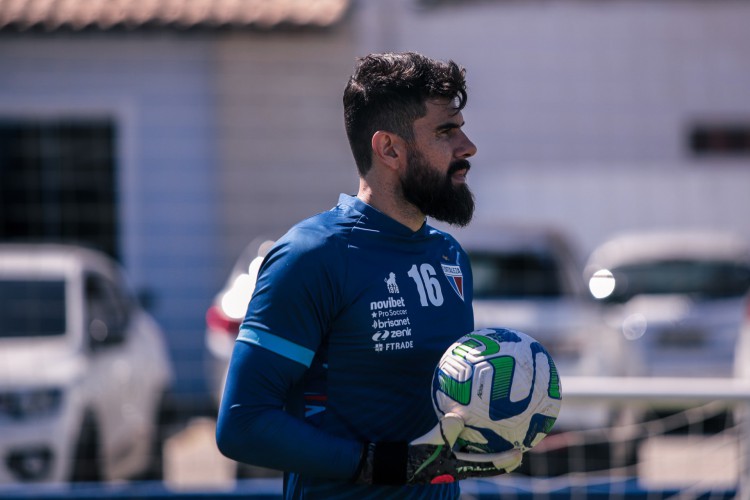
0, 0, 750, 406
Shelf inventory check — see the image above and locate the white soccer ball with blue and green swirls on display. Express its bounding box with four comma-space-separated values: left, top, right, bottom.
432, 328, 562, 453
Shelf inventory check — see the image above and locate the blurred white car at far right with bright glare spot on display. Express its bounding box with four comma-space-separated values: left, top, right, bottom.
586, 231, 750, 377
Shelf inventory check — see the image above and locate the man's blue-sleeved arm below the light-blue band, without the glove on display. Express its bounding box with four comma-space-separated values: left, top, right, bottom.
216, 342, 363, 479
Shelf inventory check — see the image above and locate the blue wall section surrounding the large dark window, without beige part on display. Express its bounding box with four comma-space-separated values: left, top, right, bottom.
0, 33, 218, 398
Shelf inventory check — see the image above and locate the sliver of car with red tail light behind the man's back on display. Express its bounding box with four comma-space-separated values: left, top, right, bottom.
205, 238, 274, 405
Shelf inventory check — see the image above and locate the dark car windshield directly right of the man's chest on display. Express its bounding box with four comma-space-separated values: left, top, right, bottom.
469, 251, 563, 299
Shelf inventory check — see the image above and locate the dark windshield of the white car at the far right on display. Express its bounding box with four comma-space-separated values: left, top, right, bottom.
608, 260, 750, 302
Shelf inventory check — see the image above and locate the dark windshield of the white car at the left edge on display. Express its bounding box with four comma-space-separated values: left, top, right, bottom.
0, 279, 65, 338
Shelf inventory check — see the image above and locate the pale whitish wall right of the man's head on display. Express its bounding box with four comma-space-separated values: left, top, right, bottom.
357, 0, 750, 254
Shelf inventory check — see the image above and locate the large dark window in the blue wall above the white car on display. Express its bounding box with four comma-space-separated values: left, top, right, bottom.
0, 119, 118, 258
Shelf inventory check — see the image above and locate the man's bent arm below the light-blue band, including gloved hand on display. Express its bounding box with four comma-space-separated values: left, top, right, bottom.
216, 342, 521, 484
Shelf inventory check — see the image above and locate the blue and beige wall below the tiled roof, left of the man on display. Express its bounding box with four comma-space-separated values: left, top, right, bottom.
0, 25, 357, 404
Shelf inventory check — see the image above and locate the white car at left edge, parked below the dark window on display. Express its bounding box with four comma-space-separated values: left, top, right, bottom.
0, 244, 172, 485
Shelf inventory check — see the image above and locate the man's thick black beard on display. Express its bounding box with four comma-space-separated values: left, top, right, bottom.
401, 146, 474, 227
